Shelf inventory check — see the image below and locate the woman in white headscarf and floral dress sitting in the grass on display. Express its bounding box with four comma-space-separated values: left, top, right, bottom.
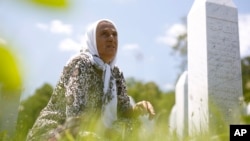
27, 19, 155, 140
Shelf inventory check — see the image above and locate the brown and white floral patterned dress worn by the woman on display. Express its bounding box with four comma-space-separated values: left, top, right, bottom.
27, 53, 138, 141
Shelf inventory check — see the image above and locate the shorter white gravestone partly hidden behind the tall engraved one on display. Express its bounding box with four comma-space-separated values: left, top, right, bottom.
175, 71, 188, 138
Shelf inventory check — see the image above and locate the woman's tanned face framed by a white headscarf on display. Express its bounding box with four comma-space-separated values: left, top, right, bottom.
96, 21, 118, 63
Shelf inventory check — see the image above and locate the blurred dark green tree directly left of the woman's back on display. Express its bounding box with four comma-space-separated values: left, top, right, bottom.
14, 83, 53, 141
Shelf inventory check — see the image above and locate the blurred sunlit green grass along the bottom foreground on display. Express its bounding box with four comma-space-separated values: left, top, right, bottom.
0, 92, 249, 141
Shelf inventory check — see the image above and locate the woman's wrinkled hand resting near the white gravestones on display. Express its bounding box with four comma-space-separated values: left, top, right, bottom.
133, 101, 155, 120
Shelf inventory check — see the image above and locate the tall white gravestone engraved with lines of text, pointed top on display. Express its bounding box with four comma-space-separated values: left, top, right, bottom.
187, 0, 242, 135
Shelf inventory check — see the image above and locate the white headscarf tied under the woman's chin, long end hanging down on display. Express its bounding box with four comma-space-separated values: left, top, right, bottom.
83, 19, 117, 128
